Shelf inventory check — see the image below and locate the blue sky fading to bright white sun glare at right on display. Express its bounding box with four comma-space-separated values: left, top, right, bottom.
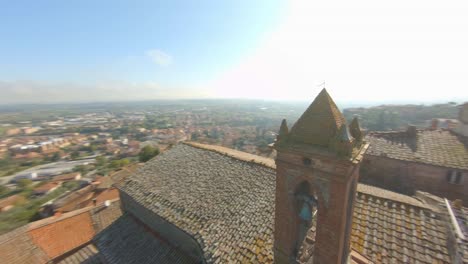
0, 0, 468, 104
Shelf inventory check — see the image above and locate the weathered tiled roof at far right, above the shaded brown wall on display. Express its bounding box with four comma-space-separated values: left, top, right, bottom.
366, 130, 468, 170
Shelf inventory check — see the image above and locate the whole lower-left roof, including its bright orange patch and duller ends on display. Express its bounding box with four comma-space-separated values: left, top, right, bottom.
0, 200, 122, 264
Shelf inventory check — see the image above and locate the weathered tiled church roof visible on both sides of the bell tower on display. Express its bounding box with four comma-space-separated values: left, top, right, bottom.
119, 144, 450, 263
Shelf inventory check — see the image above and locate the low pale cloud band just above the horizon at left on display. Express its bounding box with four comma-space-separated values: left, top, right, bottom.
0, 81, 210, 104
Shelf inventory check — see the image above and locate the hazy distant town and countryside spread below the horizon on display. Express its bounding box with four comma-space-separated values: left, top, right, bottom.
0, 100, 459, 233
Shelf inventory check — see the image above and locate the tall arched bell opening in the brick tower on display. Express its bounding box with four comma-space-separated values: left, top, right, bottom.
294, 181, 318, 262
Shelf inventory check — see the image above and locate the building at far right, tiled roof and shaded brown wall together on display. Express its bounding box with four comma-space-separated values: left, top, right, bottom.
360, 104, 468, 205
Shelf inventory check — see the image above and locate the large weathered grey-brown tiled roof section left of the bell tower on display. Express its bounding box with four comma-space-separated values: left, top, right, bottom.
120, 144, 275, 263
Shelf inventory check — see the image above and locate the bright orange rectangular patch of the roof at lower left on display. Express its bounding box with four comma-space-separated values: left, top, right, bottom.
29, 211, 95, 258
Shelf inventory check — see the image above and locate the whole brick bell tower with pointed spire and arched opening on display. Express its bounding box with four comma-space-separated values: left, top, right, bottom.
274, 89, 368, 264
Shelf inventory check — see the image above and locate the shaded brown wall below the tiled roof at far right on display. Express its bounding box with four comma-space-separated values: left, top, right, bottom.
359, 155, 468, 205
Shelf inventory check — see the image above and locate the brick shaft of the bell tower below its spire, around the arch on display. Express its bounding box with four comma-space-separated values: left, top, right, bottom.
275, 152, 359, 264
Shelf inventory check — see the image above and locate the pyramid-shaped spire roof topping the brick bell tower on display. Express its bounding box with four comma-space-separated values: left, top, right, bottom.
289, 88, 346, 147
